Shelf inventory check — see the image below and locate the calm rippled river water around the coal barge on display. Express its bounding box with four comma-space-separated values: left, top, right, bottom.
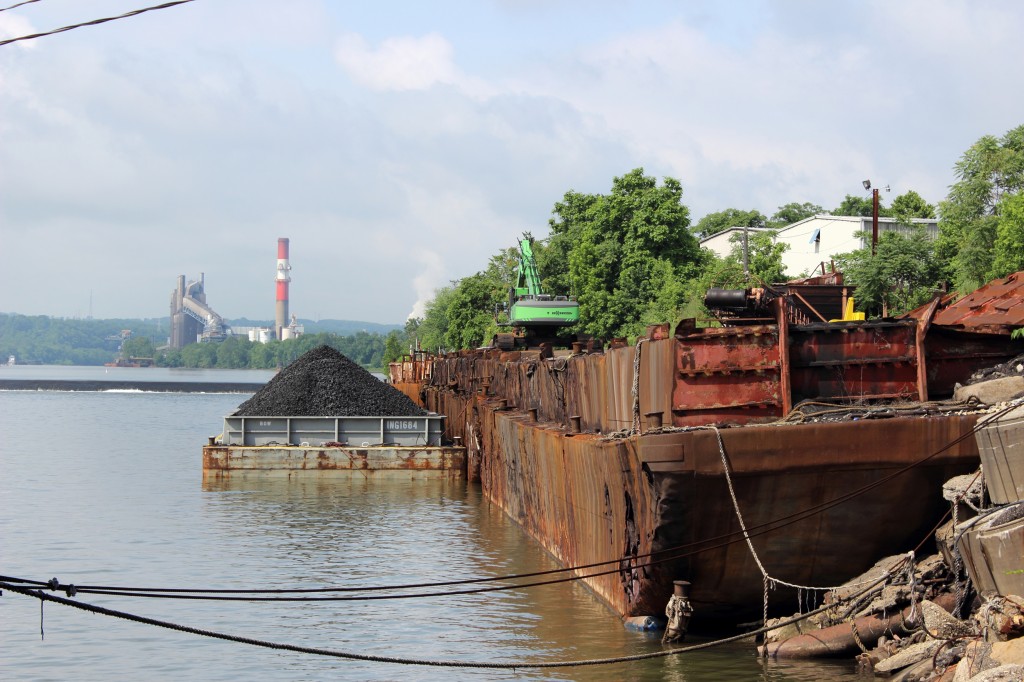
0, 368, 864, 682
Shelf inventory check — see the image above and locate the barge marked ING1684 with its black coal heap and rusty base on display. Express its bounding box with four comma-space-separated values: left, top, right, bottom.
203, 346, 465, 478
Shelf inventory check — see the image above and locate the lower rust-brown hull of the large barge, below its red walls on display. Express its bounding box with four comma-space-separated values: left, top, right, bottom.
428, 393, 977, 626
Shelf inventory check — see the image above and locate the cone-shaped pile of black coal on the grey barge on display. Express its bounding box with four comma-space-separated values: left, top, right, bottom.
234, 346, 427, 417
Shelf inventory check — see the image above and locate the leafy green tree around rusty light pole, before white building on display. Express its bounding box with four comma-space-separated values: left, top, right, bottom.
836, 226, 942, 315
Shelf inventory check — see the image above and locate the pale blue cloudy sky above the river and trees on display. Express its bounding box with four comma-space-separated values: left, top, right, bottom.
0, 0, 1024, 324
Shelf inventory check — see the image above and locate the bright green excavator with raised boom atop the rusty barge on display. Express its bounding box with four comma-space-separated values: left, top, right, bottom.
494, 236, 580, 350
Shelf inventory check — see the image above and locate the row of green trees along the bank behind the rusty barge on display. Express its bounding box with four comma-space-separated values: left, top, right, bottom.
399, 121, 1024, 350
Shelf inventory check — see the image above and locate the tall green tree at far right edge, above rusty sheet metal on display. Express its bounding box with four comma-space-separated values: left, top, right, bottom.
937, 125, 1024, 293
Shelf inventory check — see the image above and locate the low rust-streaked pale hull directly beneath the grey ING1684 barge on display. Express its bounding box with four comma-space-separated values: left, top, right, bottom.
203, 445, 466, 478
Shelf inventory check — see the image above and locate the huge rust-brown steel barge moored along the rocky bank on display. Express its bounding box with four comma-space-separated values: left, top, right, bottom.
390, 274, 1022, 627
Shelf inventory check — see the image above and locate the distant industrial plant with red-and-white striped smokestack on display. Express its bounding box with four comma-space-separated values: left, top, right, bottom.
169, 237, 304, 348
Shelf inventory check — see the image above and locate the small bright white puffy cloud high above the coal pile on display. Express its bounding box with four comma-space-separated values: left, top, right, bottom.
334, 33, 460, 90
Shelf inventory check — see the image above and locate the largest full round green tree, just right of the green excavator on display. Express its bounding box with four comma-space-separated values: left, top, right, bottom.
544, 168, 707, 338
